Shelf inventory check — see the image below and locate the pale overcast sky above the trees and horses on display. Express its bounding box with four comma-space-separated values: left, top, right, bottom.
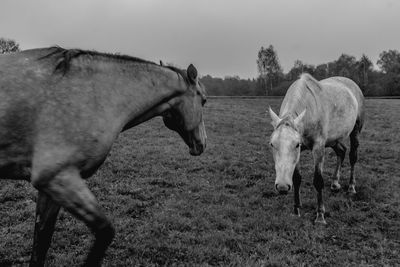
0, 0, 400, 78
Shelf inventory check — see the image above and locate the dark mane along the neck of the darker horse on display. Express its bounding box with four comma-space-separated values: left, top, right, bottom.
39, 46, 188, 81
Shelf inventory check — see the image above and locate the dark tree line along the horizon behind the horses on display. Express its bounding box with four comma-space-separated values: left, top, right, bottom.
0, 38, 400, 96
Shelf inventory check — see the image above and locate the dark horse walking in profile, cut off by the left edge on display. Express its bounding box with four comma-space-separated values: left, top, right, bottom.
0, 47, 206, 266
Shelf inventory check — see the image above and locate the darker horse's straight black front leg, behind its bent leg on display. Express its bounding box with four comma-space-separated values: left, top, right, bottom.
29, 191, 60, 267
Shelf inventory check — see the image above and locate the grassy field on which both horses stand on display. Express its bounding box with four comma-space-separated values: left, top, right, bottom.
0, 99, 400, 266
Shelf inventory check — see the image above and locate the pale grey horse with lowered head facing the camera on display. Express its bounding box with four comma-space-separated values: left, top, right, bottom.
269, 74, 364, 224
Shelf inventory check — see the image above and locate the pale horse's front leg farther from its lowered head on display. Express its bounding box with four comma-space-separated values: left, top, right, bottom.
312, 144, 326, 224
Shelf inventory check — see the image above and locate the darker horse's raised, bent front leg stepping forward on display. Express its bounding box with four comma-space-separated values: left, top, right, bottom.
34, 168, 114, 266
